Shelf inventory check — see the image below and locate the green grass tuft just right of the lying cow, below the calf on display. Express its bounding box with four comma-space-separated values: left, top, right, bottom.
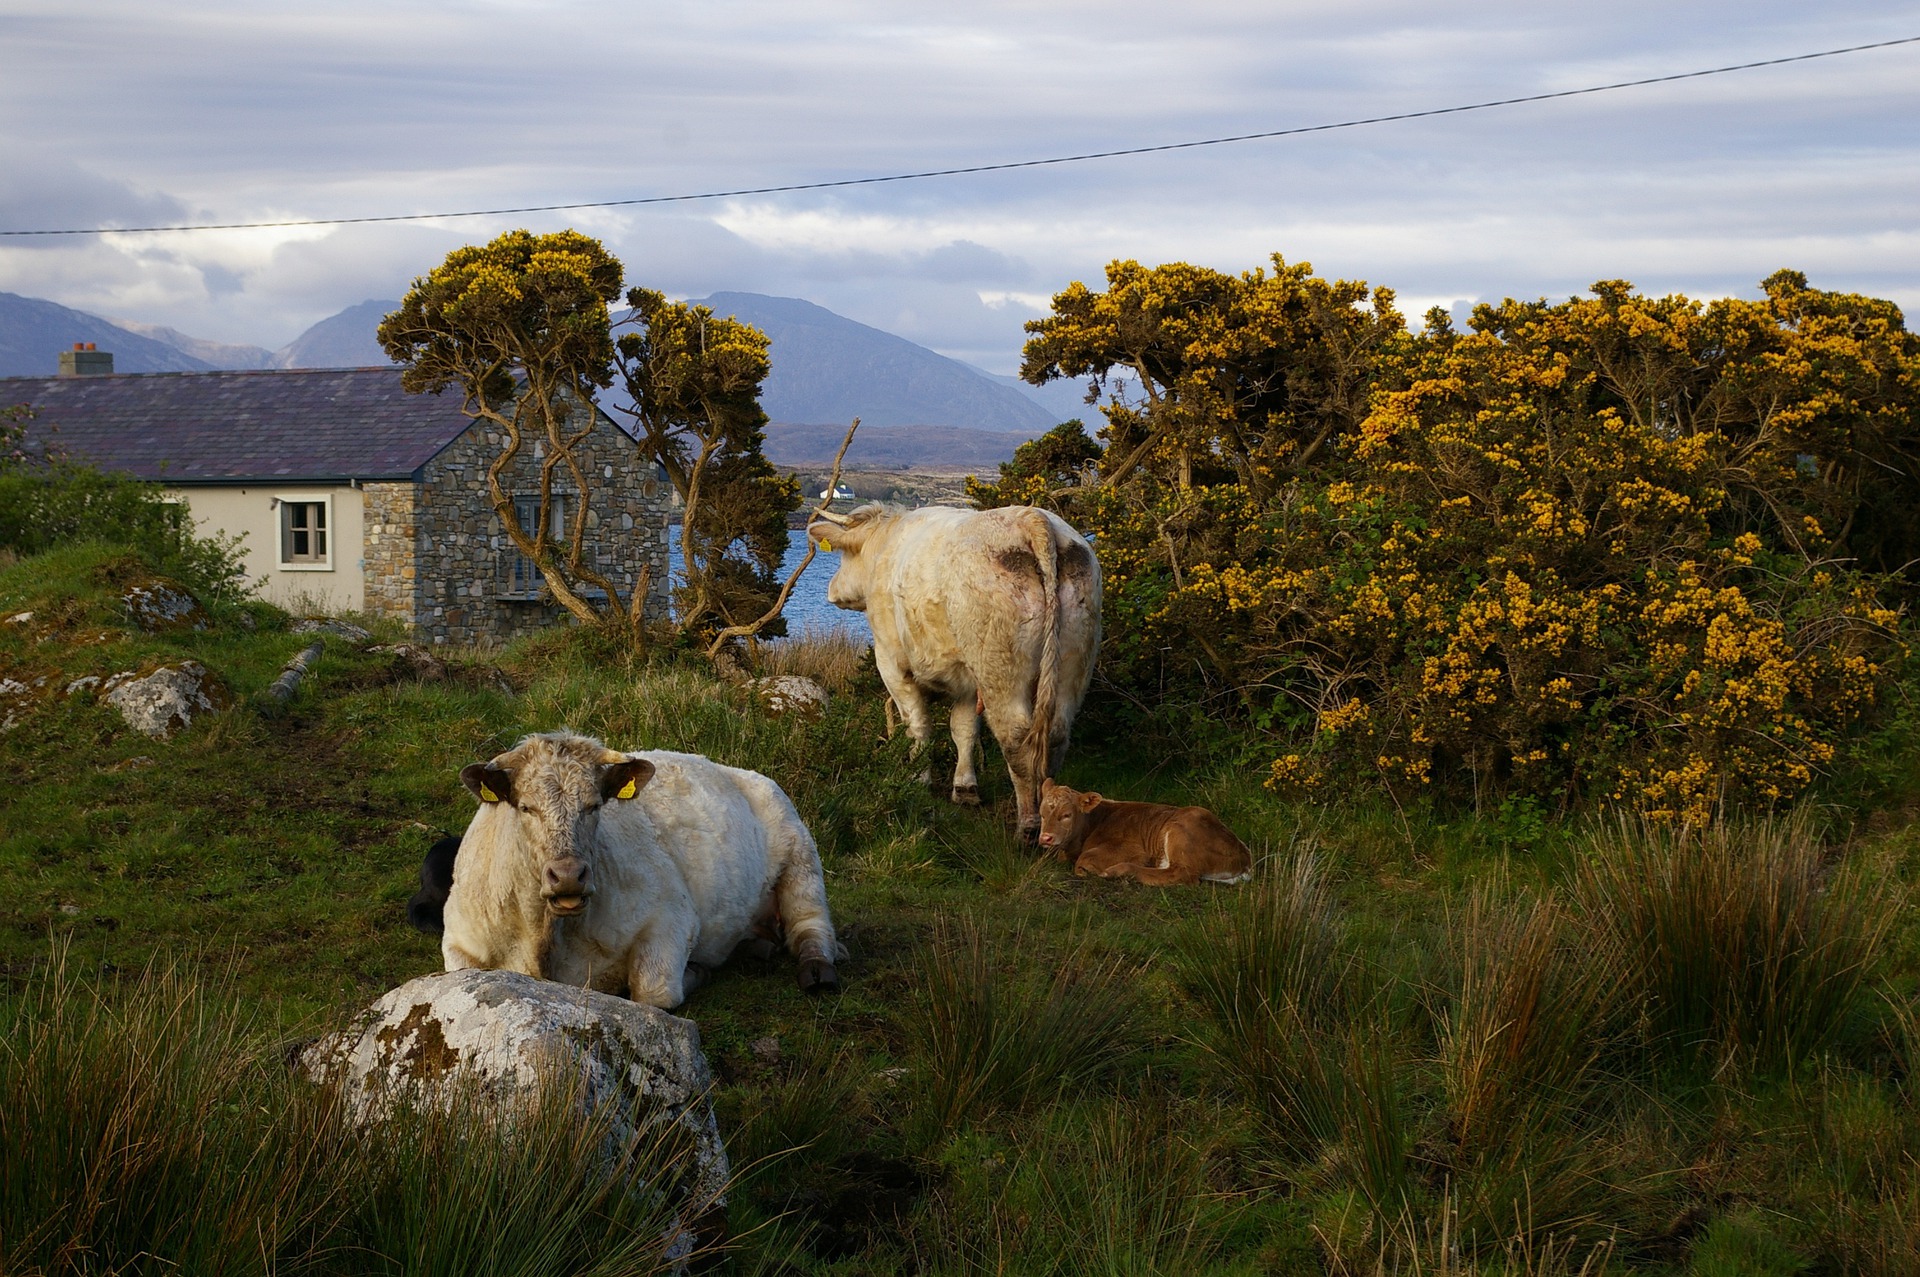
918, 920, 1137, 1135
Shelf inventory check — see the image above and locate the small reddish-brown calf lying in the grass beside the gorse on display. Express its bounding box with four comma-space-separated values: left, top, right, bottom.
1041, 780, 1254, 887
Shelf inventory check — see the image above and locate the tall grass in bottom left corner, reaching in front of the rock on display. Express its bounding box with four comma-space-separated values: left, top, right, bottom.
0, 954, 721, 1277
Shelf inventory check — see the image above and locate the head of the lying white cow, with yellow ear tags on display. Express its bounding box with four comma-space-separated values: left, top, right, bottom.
461, 732, 653, 918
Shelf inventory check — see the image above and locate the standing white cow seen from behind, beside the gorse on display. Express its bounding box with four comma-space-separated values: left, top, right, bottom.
806, 503, 1100, 837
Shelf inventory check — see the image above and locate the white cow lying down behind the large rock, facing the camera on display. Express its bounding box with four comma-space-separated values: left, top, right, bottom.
440, 732, 839, 1008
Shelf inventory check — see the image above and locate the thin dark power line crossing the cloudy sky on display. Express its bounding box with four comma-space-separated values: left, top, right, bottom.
0, 35, 1920, 236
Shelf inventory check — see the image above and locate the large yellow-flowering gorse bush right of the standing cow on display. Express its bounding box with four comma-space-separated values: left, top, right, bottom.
998, 259, 1920, 822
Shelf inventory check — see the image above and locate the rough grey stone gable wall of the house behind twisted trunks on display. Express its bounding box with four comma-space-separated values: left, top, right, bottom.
399, 410, 672, 643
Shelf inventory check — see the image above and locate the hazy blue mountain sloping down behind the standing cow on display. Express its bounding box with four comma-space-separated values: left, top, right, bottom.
701, 292, 1056, 438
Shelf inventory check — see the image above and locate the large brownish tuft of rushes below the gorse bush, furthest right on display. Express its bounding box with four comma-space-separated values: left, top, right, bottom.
1574, 814, 1891, 1072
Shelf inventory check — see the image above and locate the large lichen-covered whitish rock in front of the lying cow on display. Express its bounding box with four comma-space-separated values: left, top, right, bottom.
296, 970, 728, 1231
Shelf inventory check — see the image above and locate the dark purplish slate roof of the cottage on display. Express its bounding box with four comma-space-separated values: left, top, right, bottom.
0, 369, 472, 484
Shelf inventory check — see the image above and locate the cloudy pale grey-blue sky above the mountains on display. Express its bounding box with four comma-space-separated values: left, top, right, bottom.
0, 0, 1920, 373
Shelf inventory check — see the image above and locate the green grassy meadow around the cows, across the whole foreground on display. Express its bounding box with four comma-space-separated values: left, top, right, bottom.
0, 545, 1920, 1277
